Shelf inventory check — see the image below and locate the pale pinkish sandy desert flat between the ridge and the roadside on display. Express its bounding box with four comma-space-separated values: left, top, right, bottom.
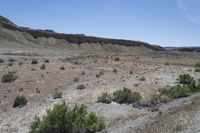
0, 48, 200, 133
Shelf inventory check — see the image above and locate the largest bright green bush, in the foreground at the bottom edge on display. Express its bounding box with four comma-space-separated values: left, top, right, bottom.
30, 102, 105, 133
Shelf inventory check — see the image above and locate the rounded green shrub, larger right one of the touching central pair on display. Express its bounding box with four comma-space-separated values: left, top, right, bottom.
112, 88, 142, 104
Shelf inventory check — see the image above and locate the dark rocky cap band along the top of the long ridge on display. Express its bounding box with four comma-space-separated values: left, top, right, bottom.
0, 16, 164, 51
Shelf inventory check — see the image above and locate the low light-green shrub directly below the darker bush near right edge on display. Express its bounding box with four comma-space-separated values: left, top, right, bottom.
168, 85, 191, 98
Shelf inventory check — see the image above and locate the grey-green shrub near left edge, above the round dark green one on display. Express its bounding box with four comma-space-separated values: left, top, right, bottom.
1, 72, 18, 83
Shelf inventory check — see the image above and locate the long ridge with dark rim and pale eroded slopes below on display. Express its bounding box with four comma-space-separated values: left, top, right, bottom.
0, 16, 164, 52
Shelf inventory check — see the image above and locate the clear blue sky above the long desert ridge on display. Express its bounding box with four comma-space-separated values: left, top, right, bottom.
0, 0, 200, 46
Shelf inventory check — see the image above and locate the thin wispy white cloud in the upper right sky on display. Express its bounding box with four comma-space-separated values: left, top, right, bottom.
177, 0, 200, 24
